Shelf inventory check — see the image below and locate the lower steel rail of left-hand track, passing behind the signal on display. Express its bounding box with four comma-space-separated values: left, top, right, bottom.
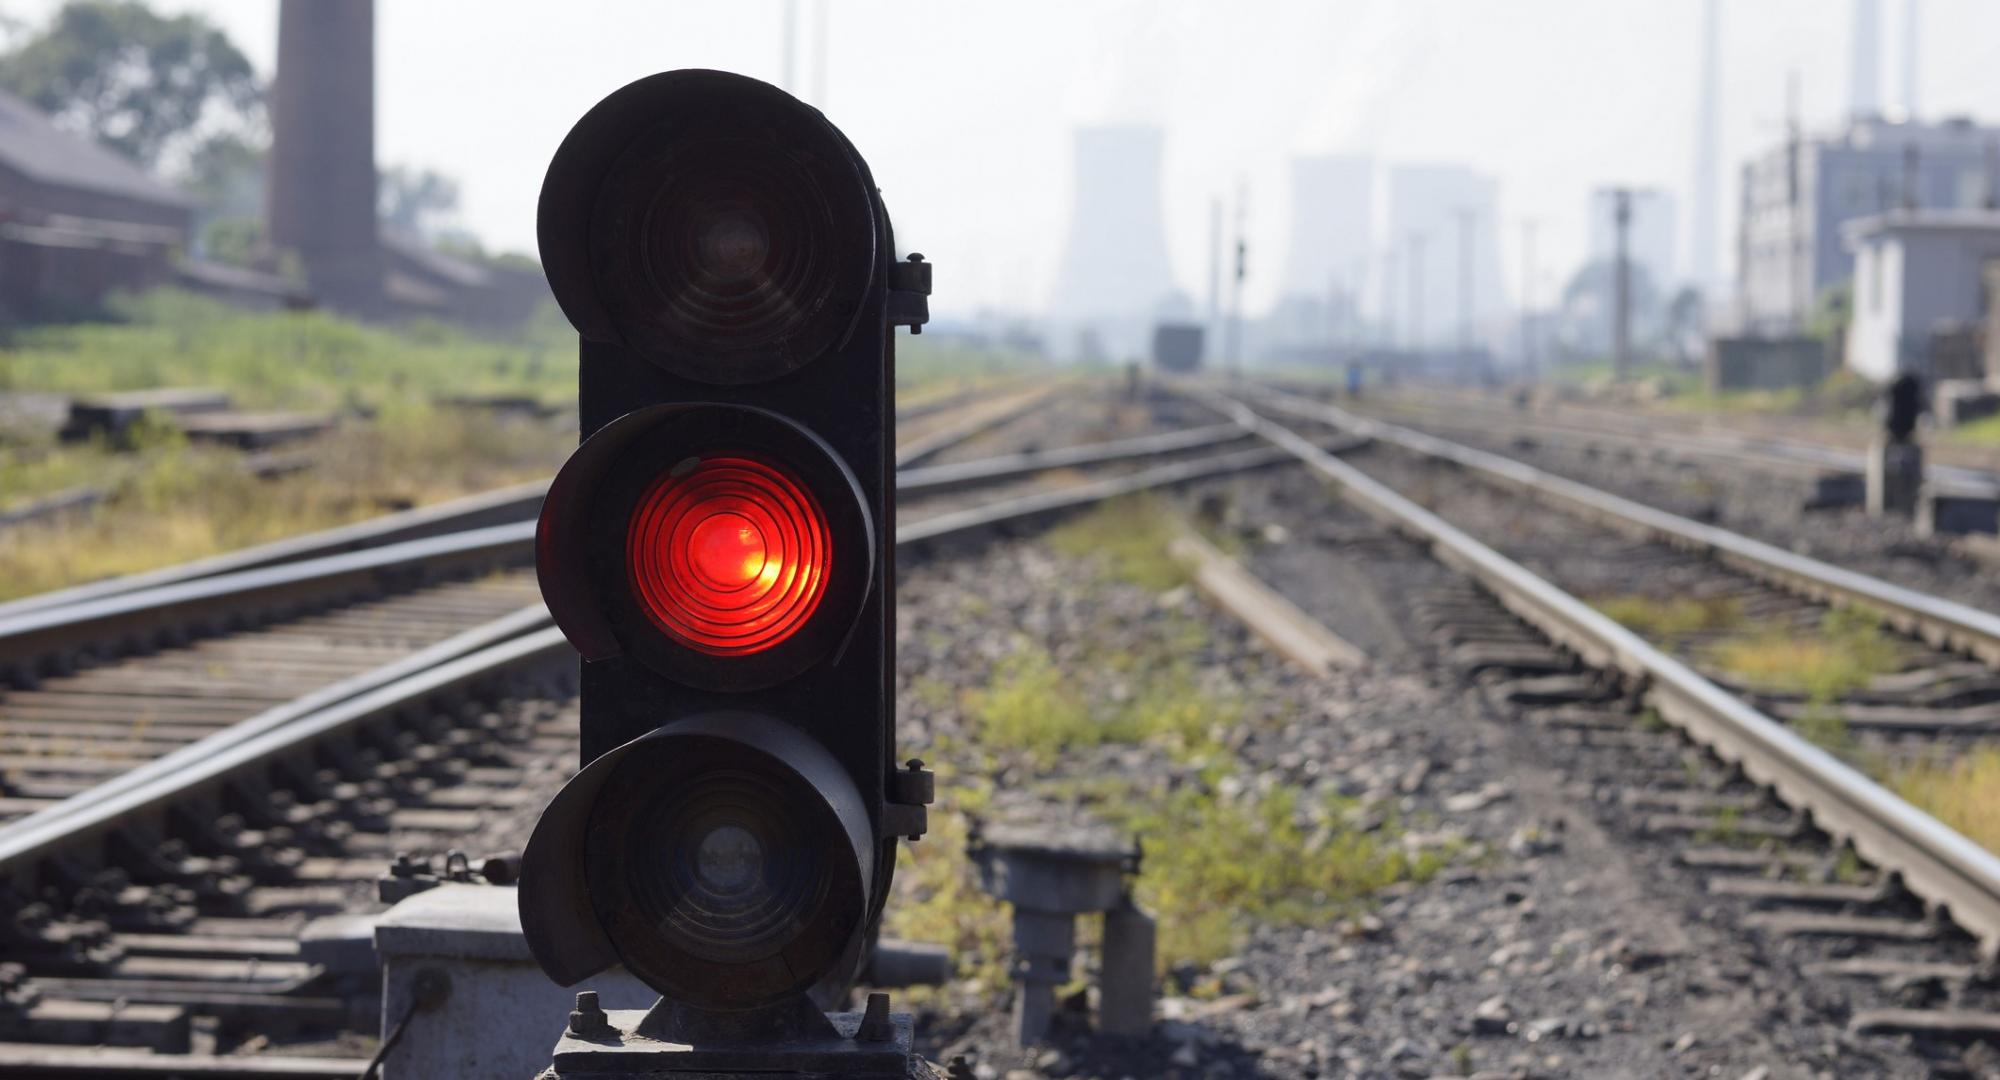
0, 446, 1312, 876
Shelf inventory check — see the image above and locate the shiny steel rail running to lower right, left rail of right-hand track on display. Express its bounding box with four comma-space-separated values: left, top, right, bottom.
1212, 396, 2000, 962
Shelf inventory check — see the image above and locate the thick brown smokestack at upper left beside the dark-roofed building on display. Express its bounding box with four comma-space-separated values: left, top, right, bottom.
264, 0, 384, 314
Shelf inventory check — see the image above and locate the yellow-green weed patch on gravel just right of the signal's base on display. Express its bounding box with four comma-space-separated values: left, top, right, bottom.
890, 500, 1452, 992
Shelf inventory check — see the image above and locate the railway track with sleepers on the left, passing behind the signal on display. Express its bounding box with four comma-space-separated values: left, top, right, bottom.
0, 384, 1282, 1076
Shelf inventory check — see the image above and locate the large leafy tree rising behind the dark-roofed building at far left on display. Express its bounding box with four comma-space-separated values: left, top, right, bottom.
0, 0, 264, 168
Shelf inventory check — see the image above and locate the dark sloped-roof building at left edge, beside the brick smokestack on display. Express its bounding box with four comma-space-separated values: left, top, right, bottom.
0, 94, 194, 320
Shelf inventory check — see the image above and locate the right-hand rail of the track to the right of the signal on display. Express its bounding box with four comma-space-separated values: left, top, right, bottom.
1256, 390, 2000, 666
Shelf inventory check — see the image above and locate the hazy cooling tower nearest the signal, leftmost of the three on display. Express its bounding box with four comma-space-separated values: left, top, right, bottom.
1048, 124, 1176, 358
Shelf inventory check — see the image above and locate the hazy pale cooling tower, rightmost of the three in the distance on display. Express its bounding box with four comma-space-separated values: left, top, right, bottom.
1382, 166, 1510, 350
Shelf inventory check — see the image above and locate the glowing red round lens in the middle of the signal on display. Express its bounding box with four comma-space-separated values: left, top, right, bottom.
626, 456, 832, 656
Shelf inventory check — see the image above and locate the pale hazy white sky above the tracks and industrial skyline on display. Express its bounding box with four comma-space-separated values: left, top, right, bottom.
11, 0, 2000, 316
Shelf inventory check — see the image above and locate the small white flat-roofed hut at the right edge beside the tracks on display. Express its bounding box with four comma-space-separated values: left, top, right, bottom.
1842, 210, 2000, 380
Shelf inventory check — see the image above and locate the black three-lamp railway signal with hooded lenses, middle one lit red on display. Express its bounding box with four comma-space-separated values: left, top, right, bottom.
508, 70, 930, 1076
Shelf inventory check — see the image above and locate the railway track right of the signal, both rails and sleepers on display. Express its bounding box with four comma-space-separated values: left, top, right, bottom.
1212, 392, 2000, 1044
